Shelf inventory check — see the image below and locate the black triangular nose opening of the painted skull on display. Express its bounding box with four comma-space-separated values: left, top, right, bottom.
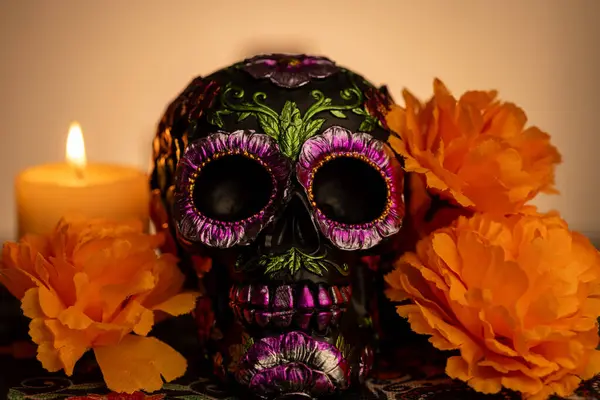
264, 193, 321, 254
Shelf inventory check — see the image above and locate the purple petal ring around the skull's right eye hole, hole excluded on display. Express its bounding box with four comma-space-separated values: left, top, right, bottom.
296, 126, 404, 250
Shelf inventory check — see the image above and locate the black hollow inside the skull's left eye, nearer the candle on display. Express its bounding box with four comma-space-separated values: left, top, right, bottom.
192, 154, 274, 222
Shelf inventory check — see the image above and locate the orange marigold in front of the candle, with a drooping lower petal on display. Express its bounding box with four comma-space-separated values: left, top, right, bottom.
0, 220, 202, 393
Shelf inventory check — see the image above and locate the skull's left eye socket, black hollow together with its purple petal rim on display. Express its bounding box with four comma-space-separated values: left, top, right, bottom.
173, 131, 291, 248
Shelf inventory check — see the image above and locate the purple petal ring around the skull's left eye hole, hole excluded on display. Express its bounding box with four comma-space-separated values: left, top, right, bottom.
174, 131, 291, 248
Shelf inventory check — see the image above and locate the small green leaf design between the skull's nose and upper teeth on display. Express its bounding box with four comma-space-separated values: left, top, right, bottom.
256, 248, 338, 278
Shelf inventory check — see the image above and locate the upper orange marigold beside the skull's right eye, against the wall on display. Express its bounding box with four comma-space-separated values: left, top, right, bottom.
386, 79, 561, 214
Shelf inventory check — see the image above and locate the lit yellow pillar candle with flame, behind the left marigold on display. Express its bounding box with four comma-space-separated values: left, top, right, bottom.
15, 123, 150, 238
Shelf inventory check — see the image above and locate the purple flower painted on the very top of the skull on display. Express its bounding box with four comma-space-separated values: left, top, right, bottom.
243, 54, 339, 89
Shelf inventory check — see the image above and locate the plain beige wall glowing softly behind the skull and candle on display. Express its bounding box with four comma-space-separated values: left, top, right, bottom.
0, 0, 600, 244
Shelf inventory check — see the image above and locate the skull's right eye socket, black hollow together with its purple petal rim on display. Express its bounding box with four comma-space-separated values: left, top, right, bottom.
296, 126, 404, 250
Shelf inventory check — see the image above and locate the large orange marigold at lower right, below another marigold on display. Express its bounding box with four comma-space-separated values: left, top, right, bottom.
386, 209, 600, 399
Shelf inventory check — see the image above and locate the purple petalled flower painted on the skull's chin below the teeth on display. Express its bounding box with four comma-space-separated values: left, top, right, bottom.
236, 332, 350, 397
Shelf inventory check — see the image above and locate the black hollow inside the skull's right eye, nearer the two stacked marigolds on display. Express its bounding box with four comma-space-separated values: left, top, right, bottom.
312, 157, 388, 224
